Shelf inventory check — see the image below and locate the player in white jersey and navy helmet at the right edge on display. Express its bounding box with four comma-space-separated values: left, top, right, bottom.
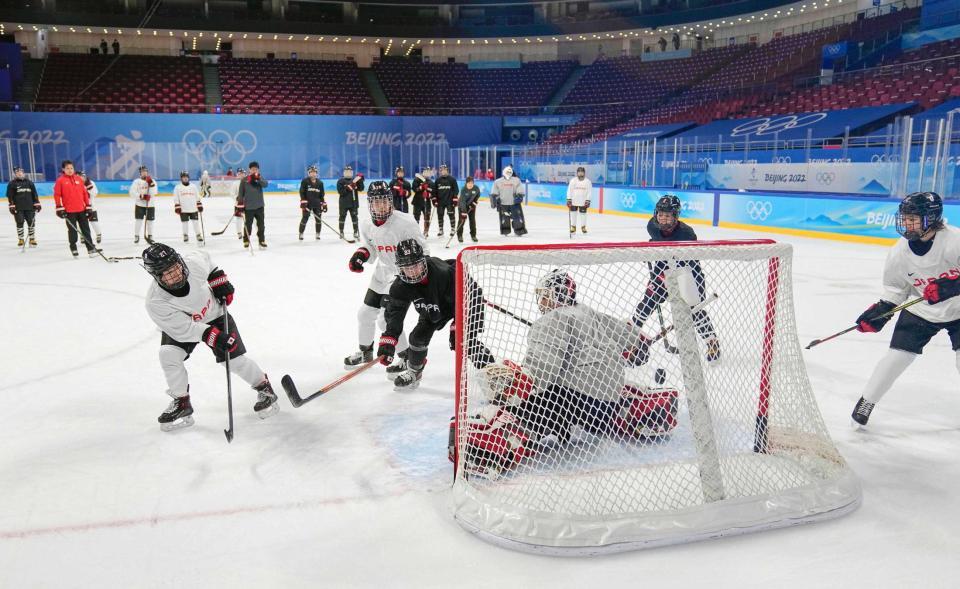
852, 192, 960, 426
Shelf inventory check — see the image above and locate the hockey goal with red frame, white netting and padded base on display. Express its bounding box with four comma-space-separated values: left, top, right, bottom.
450, 240, 860, 554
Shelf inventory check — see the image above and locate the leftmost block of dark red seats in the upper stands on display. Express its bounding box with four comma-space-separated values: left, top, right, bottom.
37, 53, 206, 113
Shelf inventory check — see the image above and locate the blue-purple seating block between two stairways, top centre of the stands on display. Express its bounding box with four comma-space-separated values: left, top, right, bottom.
374, 60, 576, 115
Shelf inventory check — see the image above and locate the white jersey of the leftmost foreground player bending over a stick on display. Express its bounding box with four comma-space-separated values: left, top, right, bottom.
146, 251, 223, 343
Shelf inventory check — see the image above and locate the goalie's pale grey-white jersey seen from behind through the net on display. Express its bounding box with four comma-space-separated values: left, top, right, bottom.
523, 305, 640, 401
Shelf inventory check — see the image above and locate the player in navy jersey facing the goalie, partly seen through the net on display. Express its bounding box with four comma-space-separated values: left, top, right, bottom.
633, 194, 720, 362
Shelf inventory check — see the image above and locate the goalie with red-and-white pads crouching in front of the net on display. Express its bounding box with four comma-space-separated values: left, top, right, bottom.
451, 270, 677, 476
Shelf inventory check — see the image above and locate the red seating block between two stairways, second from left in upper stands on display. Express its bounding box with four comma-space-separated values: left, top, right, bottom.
218, 58, 375, 114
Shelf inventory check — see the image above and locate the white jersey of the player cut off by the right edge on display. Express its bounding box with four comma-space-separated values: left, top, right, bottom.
880, 225, 960, 323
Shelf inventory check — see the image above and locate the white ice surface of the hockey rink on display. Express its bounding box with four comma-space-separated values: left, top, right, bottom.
0, 196, 960, 589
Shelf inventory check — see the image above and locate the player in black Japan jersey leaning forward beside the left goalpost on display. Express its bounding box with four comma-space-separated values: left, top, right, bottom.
377, 239, 495, 390
